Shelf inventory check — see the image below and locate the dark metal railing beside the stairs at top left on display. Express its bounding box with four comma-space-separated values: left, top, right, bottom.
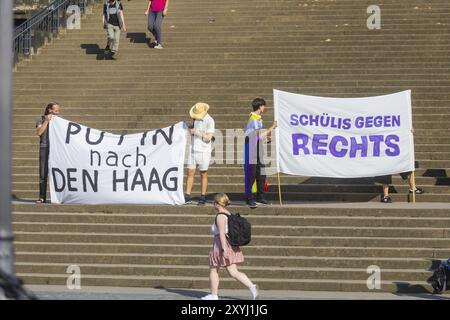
14, 0, 96, 62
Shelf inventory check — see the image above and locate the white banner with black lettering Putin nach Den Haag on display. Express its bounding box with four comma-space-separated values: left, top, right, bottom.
49, 117, 187, 204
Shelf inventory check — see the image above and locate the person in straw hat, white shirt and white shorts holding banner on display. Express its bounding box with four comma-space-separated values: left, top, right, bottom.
185, 102, 215, 205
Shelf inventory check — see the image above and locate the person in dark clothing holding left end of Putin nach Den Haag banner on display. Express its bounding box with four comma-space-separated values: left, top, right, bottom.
36, 102, 59, 203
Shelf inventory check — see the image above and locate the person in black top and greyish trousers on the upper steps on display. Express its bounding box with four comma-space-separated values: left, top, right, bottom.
102, 0, 127, 59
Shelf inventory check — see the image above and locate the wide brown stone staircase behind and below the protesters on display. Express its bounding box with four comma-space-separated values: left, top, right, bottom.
13, 0, 450, 292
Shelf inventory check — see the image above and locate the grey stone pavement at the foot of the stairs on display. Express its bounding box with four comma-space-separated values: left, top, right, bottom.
27, 285, 450, 300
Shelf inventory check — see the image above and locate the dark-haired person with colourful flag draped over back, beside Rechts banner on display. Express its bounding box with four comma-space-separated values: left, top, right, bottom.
244, 98, 277, 208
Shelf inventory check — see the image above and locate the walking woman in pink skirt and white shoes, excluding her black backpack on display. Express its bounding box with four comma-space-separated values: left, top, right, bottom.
202, 193, 258, 300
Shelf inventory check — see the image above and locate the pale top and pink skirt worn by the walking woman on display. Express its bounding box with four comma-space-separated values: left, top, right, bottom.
209, 218, 244, 267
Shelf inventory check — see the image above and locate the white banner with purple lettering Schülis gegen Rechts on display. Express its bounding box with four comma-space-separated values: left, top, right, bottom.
274, 90, 414, 178
